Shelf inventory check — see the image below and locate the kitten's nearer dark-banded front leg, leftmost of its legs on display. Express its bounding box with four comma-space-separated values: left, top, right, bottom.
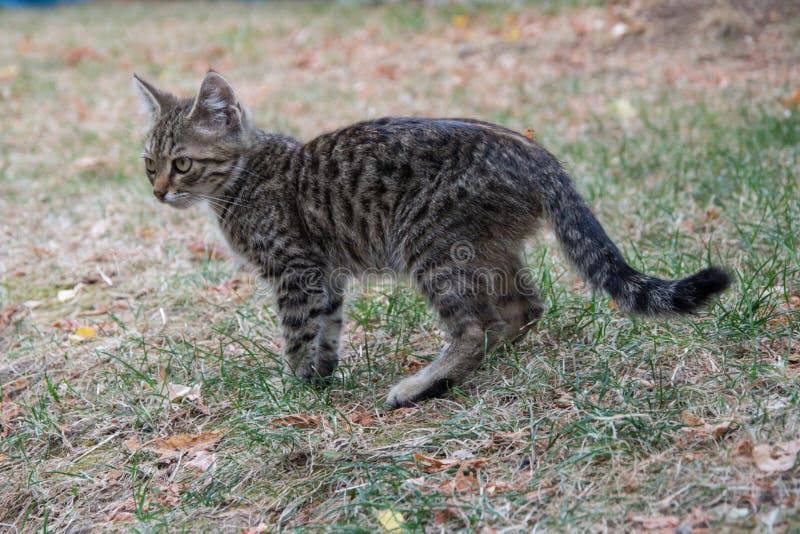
277, 267, 327, 380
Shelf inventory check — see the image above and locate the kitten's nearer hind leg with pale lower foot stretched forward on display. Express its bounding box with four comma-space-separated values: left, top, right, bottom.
387, 266, 508, 408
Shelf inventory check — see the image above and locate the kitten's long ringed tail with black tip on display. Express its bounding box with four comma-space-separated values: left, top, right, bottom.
537, 159, 730, 316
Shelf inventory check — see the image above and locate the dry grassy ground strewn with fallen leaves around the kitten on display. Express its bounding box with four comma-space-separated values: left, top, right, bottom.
0, 0, 800, 532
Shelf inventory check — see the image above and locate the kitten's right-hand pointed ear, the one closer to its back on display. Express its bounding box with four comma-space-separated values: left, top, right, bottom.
188, 70, 245, 130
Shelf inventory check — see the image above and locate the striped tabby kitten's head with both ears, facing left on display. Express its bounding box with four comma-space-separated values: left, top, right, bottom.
133, 71, 256, 208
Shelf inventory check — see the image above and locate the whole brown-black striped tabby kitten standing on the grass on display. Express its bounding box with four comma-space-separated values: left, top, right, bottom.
134, 71, 729, 407
